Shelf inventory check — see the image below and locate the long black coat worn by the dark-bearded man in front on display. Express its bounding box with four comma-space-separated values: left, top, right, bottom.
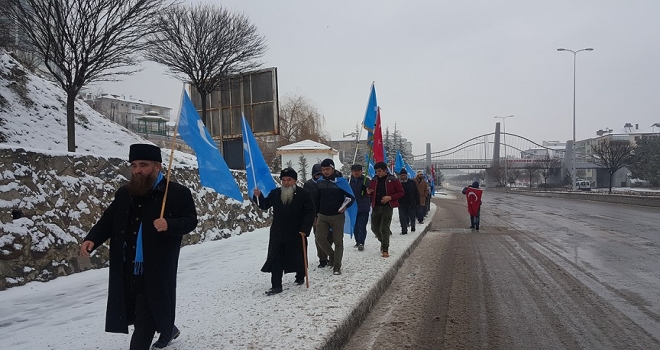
85, 179, 197, 333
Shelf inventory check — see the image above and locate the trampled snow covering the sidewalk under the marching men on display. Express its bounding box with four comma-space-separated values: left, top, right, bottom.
0, 205, 435, 350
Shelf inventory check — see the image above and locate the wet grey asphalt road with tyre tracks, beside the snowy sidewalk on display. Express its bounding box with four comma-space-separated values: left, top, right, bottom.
344, 190, 660, 349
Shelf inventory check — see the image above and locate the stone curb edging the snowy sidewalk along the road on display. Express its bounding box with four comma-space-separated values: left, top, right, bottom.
321, 221, 435, 350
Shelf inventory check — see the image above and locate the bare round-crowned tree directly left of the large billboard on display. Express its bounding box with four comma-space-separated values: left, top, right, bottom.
146, 4, 267, 125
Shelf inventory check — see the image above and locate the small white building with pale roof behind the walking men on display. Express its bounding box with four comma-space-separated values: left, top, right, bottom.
277, 140, 343, 182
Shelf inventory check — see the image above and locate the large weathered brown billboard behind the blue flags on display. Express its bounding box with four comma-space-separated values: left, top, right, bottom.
190, 67, 280, 141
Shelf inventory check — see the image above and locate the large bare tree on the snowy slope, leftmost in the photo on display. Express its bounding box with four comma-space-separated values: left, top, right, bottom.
1, 0, 164, 152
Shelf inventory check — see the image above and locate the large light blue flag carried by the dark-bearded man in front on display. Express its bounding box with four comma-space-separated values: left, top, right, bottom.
177, 91, 243, 202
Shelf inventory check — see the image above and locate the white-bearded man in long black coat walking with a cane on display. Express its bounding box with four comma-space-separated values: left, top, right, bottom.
253, 168, 316, 295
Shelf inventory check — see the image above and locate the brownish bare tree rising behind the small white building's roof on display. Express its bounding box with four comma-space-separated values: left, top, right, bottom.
280, 95, 330, 145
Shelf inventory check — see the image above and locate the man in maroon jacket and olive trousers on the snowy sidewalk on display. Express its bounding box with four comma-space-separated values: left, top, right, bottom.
367, 162, 404, 258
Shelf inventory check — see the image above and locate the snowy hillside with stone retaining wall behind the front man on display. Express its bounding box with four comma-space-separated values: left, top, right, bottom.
0, 53, 270, 291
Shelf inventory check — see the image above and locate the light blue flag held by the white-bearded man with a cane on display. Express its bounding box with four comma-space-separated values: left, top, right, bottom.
242, 116, 277, 198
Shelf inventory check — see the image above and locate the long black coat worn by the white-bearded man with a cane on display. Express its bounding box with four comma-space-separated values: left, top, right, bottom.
254, 186, 316, 273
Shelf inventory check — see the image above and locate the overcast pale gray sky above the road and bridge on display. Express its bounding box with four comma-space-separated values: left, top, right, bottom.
96, 0, 660, 154
